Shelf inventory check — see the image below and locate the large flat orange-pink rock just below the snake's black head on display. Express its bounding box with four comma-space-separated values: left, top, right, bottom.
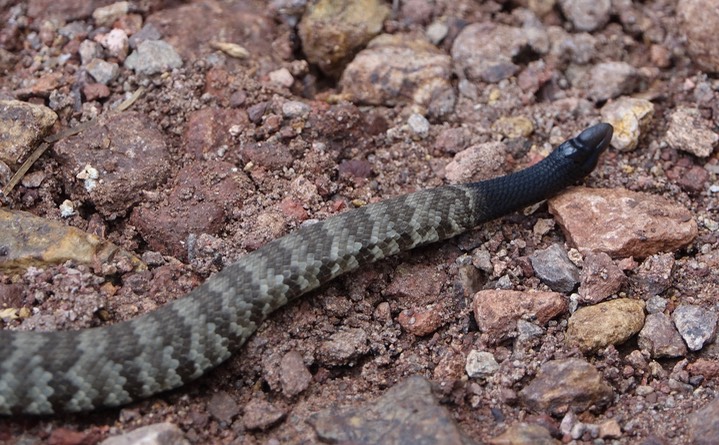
549, 187, 698, 258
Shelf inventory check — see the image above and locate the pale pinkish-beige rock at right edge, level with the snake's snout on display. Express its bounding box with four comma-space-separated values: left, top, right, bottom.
665, 107, 719, 158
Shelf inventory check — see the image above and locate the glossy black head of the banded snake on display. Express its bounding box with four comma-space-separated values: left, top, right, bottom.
558, 123, 614, 177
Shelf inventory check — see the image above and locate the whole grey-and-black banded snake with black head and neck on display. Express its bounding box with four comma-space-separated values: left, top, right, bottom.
0, 124, 612, 414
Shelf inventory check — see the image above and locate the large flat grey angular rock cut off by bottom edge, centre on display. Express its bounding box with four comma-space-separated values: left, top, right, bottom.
309, 376, 474, 445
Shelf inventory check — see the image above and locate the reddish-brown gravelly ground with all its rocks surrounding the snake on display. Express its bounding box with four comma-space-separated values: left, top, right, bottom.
0, 0, 719, 445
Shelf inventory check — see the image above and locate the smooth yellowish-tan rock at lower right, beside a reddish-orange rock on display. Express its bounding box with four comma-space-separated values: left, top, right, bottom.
566, 298, 644, 353
